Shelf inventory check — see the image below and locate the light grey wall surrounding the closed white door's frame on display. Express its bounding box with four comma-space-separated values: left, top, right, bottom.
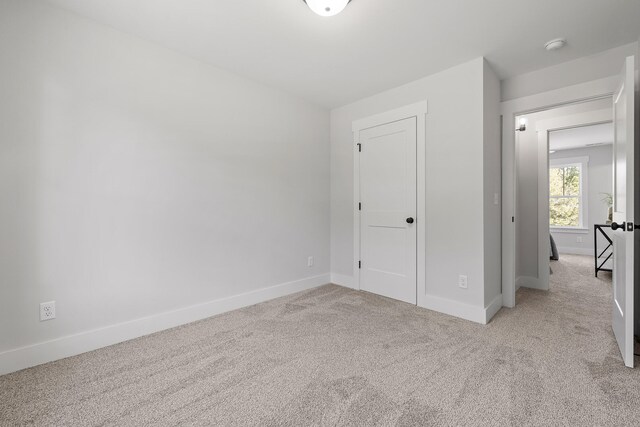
331, 58, 499, 318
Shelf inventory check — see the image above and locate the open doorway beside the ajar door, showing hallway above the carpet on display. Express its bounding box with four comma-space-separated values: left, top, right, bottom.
515, 98, 614, 290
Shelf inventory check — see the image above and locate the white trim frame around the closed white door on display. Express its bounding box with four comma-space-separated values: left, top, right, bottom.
351, 100, 428, 305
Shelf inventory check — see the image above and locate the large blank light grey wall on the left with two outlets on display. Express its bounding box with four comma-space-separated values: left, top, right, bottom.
0, 0, 330, 353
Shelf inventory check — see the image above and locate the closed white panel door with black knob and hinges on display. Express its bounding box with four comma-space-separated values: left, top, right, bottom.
358, 117, 418, 304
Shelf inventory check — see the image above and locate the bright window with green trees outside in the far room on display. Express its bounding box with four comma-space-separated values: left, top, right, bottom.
549, 157, 589, 229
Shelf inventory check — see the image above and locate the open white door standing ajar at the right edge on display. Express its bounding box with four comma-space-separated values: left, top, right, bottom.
612, 56, 635, 367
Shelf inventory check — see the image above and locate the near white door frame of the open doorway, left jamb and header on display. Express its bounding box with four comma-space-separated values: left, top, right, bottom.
501, 76, 618, 307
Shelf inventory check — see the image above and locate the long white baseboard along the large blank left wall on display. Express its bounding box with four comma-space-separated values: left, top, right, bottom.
0, 273, 330, 375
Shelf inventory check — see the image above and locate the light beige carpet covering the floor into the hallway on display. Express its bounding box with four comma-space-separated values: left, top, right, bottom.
0, 255, 640, 426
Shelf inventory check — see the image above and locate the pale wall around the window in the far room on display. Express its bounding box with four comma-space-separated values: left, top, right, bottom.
549, 145, 613, 255
